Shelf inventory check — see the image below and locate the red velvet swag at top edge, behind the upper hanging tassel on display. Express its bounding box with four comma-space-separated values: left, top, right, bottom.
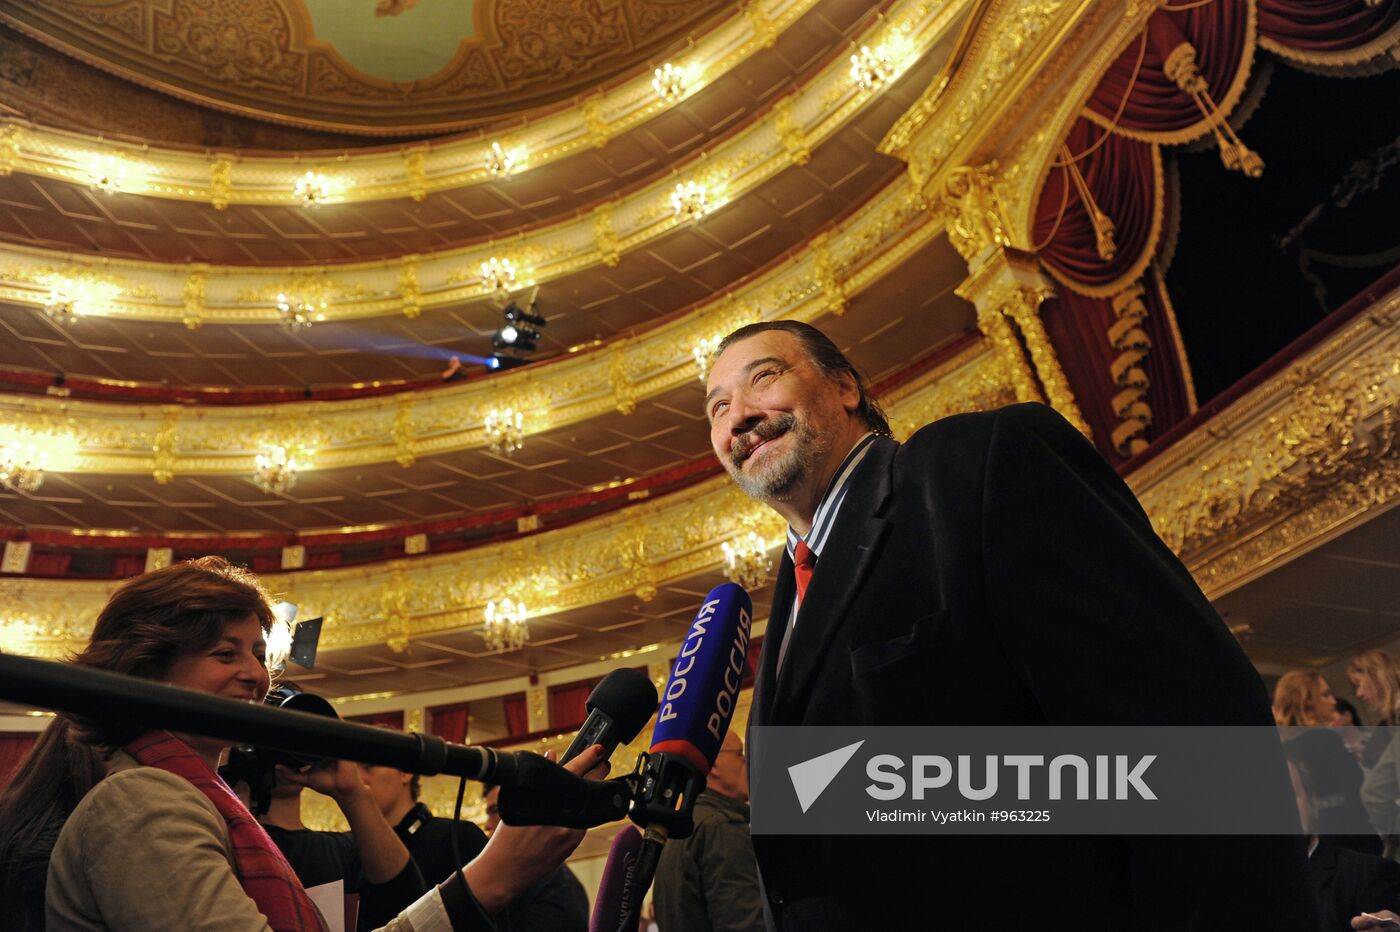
1086, 0, 1254, 141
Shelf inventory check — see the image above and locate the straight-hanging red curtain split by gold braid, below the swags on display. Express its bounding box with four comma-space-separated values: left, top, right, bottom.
1040, 264, 1190, 463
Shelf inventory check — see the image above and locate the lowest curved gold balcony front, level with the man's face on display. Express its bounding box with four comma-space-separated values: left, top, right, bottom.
0, 344, 1009, 656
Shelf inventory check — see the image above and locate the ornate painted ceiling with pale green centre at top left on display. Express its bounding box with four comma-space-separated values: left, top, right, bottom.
0, 0, 731, 136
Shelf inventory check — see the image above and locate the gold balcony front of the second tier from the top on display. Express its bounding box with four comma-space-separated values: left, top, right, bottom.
0, 0, 965, 325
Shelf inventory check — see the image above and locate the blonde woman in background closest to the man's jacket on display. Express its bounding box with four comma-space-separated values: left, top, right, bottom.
1274, 670, 1382, 855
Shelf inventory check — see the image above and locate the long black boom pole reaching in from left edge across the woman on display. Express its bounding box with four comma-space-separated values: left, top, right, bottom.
0, 654, 576, 794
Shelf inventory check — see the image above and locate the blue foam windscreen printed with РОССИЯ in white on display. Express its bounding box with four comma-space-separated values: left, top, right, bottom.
651, 582, 753, 775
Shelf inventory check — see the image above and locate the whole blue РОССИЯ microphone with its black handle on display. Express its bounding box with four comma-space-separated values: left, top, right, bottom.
617, 582, 753, 929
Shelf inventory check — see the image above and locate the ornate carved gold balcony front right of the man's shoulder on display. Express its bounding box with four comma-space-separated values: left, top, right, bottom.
1130, 282, 1400, 596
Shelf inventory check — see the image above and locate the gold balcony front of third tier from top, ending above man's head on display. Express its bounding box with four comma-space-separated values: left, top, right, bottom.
0, 167, 941, 474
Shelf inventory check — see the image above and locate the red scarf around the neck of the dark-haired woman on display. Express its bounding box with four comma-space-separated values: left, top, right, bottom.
123, 732, 325, 932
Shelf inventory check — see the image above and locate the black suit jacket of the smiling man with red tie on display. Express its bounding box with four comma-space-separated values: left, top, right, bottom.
750, 404, 1316, 932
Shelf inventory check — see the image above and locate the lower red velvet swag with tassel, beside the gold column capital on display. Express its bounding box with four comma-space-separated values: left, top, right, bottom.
1035, 118, 1162, 291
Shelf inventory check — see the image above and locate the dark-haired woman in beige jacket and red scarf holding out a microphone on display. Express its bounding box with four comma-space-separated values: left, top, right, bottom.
0, 557, 601, 932
